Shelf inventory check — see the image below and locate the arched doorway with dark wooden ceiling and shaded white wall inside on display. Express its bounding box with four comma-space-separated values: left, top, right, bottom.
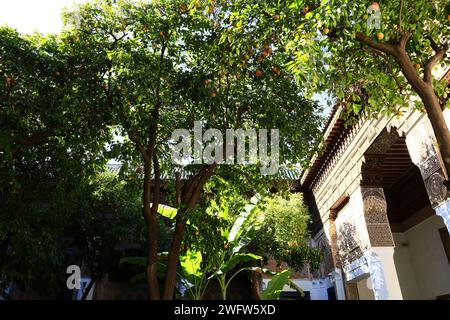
358, 129, 450, 299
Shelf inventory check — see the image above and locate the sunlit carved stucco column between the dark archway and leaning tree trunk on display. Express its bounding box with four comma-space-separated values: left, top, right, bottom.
406, 117, 450, 232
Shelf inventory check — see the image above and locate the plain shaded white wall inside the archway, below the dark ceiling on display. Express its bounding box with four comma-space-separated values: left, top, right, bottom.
394, 215, 450, 299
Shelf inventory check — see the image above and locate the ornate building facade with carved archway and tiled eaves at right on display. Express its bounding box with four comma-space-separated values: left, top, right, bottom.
300, 72, 450, 300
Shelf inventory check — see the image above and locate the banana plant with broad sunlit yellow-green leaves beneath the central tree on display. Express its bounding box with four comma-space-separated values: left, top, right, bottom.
120, 197, 303, 300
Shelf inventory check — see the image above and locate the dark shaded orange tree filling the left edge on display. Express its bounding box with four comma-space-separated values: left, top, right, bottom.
0, 27, 110, 295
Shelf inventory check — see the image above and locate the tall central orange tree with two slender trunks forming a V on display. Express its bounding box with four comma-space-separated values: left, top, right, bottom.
63, 0, 320, 299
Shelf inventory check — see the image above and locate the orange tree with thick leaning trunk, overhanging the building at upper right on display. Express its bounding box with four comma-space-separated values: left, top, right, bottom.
236, 0, 450, 186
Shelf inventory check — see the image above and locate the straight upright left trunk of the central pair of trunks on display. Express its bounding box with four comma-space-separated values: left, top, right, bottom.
143, 159, 160, 300
